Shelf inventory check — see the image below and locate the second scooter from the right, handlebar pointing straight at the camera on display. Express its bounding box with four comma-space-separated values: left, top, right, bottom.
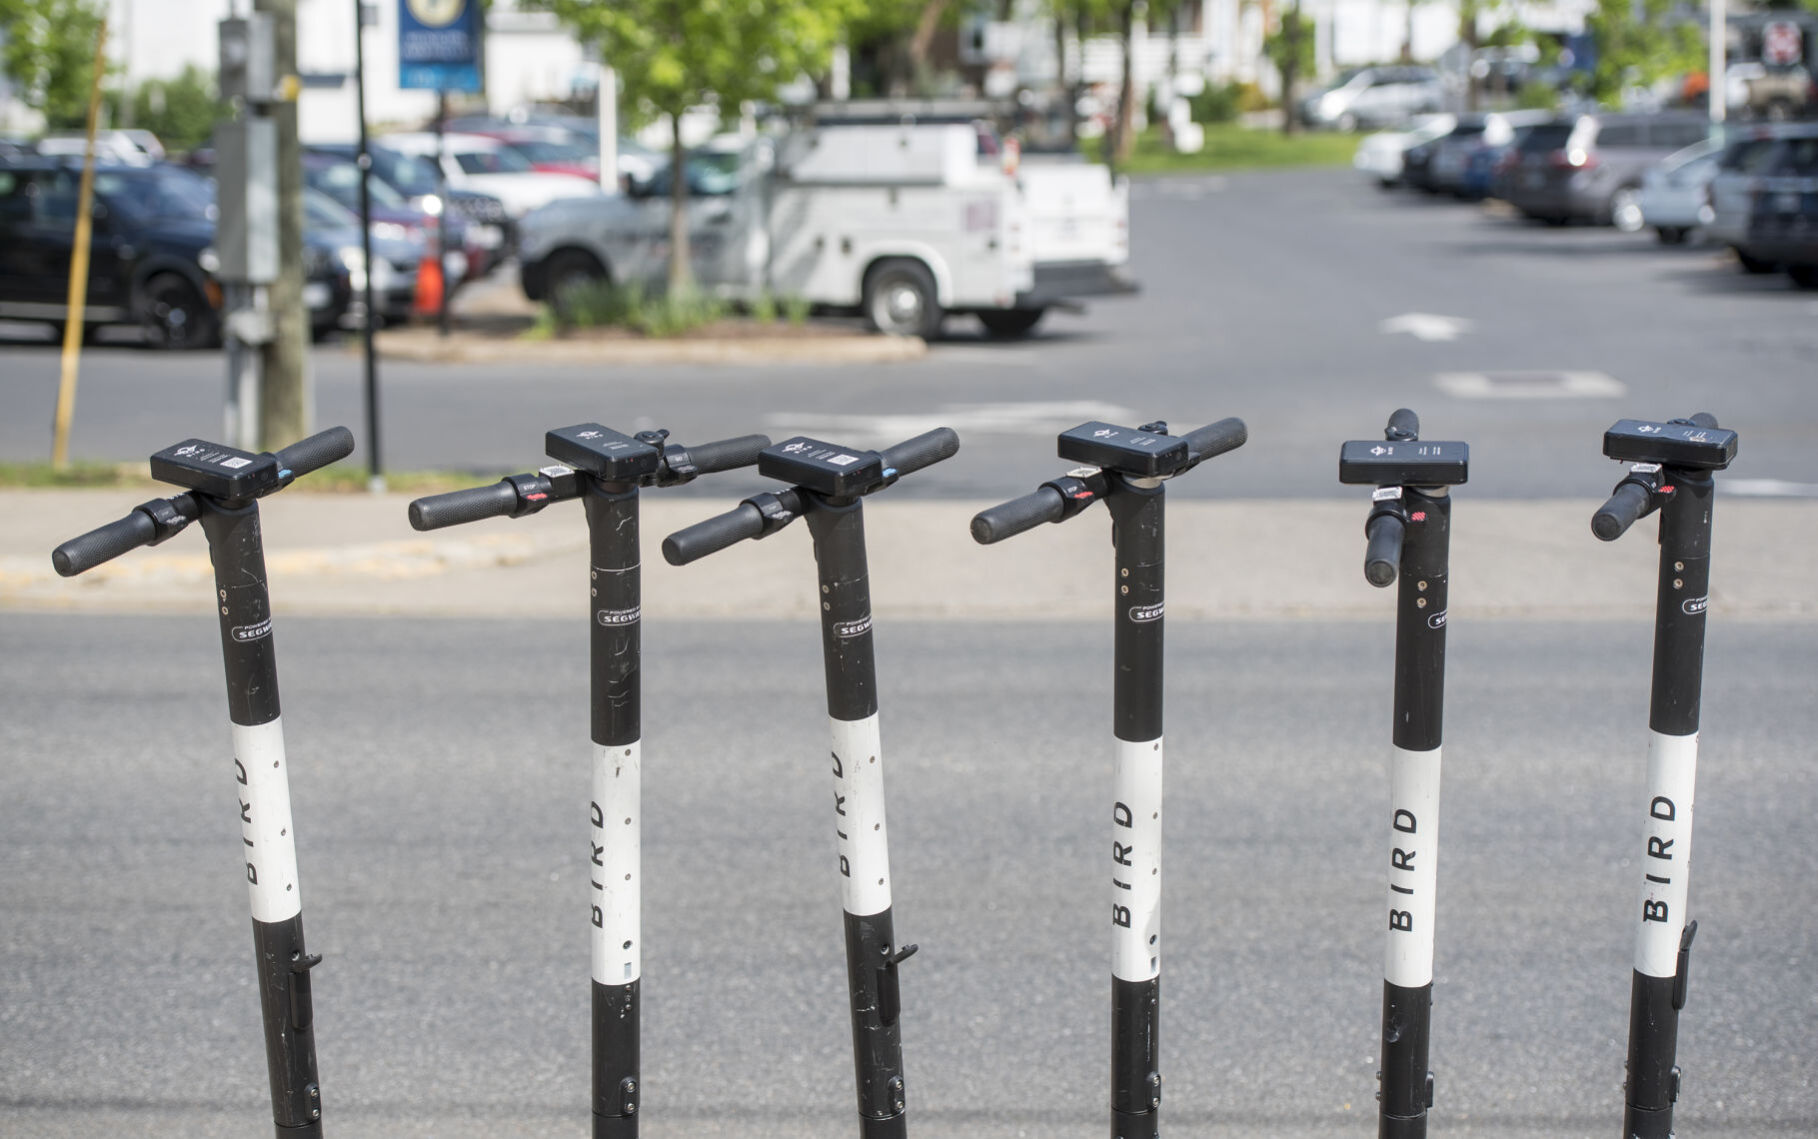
1338, 407, 1471, 1139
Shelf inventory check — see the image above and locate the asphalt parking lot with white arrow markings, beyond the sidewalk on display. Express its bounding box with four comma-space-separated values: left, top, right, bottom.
0, 171, 1818, 498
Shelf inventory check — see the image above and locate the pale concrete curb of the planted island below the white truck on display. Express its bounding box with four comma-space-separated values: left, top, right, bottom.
376, 329, 927, 367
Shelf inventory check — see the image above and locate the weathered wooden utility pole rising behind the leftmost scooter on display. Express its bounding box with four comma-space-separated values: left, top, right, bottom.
253, 0, 315, 451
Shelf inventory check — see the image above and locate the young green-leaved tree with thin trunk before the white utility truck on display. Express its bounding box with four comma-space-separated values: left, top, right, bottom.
536, 0, 862, 292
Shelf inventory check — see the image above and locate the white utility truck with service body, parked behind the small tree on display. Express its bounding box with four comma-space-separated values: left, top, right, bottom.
518, 124, 1134, 336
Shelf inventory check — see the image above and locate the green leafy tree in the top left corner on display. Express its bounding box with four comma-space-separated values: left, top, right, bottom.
0, 0, 107, 131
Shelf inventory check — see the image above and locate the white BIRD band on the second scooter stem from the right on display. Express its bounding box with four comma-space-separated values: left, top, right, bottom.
1382, 748, 1440, 988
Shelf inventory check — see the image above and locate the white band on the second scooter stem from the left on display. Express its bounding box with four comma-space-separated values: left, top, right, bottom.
587, 741, 644, 985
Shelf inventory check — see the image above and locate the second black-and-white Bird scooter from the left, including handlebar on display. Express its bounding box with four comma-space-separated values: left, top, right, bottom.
411, 423, 769, 1139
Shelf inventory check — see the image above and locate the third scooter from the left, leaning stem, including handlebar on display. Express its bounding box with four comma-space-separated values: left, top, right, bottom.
664, 427, 960, 1139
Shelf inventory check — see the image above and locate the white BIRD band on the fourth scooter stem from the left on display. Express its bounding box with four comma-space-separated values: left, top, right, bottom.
1111, 739, 1162, 981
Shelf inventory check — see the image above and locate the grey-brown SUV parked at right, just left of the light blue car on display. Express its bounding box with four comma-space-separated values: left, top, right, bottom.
1503, 111, 1711, 233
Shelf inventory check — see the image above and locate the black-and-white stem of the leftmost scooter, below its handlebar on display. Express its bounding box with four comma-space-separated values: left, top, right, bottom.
198, 496, 322, 1139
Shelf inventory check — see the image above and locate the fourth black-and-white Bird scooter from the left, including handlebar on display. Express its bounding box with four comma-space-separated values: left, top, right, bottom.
973, 420, 1249, 1139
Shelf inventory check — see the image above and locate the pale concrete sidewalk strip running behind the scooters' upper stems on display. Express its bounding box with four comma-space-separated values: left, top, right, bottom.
0, 489, 1818, 621
